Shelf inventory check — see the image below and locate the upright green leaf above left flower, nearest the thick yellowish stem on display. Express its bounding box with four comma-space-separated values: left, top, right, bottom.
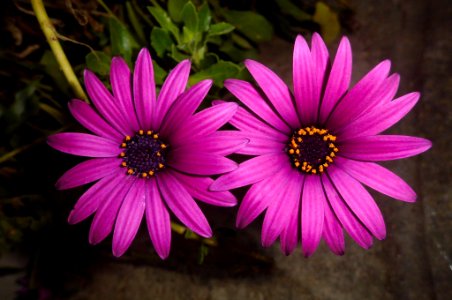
108, 18, 140, 64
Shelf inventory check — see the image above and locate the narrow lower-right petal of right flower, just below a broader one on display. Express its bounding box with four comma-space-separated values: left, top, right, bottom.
321, 175, 372, 249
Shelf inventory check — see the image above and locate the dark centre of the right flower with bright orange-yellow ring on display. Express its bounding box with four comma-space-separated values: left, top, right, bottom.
286, 126, 339, 174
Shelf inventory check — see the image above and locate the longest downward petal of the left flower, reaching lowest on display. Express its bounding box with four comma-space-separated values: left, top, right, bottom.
145, 178, 171, 259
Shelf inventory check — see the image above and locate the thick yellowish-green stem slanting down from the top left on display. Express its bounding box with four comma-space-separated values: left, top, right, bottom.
31, 0, 89, 102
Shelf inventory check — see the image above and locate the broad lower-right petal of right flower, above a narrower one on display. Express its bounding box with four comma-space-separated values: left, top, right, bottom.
328, 167, 386, 240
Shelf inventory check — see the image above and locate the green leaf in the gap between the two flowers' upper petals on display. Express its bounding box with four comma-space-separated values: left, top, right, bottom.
188, 60, 241, 87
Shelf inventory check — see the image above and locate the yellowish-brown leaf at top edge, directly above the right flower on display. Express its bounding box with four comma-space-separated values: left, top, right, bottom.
312, 1, 341, 43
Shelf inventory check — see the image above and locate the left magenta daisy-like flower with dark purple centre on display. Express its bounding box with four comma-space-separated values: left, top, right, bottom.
48, 49, 247, 258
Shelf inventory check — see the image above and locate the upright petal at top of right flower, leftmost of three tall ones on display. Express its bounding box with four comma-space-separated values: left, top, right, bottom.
293, 35, 322, 124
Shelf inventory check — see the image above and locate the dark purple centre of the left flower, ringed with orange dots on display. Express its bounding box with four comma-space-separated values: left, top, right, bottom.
119, 130, 168, 178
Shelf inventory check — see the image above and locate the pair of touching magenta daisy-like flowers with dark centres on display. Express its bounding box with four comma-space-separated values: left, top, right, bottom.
48, 34, 431, 259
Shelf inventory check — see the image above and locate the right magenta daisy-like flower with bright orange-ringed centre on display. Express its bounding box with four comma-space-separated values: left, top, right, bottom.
211, 34, 431, 256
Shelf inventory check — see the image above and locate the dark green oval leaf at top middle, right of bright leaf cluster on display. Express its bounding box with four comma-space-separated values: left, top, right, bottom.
223, 10, 273, 43
